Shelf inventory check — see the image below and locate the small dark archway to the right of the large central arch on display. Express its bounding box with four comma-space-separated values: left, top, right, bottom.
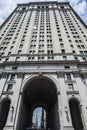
69, 99, 83, 130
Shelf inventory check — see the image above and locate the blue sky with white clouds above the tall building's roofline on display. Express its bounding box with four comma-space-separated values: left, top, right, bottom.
0, 0, 87, 25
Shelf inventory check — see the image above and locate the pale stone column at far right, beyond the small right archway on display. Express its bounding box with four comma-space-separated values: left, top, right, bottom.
73, 72, 87, 130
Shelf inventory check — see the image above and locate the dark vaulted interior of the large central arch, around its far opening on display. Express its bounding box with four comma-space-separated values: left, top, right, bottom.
17, 76, 60, 130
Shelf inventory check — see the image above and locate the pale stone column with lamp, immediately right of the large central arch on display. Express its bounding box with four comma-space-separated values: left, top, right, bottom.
57, 72, 73, 130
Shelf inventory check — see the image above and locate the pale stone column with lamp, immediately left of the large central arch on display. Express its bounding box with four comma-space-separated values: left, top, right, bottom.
3, 73, 23, 130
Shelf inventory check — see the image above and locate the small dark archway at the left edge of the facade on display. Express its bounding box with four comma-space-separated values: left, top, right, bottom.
0, 99, 11, 130
